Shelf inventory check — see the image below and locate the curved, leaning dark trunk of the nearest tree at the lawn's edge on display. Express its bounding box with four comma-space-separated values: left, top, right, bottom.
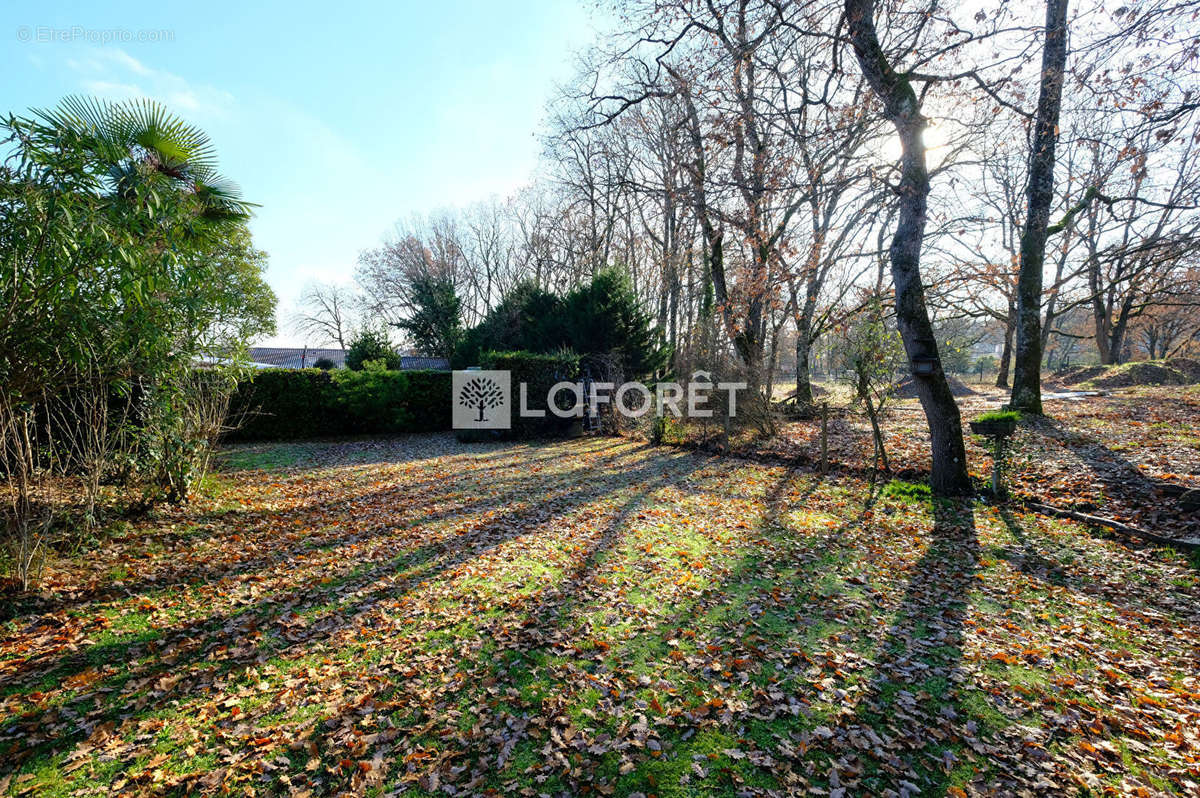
845, 0, 971, 496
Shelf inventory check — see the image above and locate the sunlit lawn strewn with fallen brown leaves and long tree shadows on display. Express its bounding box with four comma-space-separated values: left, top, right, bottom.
0, 436, 1200, 797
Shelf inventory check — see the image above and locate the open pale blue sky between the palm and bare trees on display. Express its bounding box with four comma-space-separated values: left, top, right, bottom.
0, 0, 595, 342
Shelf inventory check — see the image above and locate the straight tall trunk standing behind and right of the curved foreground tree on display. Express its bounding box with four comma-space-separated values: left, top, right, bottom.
1010, 0, 1067, 415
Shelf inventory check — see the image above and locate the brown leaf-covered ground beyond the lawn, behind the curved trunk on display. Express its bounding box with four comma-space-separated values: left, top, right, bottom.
737, 383, 1200, 540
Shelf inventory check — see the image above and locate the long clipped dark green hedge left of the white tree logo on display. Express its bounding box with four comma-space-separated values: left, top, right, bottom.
226, 368, 450, 440
